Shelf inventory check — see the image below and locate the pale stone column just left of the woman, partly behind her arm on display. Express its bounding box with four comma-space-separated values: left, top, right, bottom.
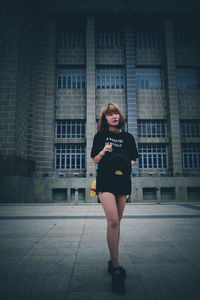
86, 17, 96, 177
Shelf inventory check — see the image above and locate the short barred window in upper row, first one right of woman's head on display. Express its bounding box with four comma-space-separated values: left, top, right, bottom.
138, 120, 167, 138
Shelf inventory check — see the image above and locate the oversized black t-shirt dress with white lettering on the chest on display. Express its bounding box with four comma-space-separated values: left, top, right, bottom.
91, 131, 139, 196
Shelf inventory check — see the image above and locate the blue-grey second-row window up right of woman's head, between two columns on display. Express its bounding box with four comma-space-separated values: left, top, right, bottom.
136, 68, 163, 90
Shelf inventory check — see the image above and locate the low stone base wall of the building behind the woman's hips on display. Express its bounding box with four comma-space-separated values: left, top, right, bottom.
0, 176, 200, 204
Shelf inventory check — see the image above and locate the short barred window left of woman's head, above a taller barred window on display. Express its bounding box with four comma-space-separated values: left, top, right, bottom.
56, 120, 86, 139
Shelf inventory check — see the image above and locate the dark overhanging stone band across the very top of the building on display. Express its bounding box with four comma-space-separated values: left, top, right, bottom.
47, 0, 199, 13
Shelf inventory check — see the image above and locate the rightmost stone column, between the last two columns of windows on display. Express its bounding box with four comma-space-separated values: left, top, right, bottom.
164, 17, 182, 176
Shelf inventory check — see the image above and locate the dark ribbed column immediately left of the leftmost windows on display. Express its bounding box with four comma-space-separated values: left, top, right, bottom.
28, 15, 47, 177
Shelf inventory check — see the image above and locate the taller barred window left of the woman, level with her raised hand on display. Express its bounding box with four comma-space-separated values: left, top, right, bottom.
55, 145, 86, 170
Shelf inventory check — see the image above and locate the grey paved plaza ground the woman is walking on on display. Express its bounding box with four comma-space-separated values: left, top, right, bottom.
0, 203, 200, 300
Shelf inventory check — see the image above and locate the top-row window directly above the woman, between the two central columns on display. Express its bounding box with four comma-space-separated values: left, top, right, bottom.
96, 32, 122, 48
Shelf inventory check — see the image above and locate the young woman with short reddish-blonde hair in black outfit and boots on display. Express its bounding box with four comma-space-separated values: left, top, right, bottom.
91, 103, 138, 294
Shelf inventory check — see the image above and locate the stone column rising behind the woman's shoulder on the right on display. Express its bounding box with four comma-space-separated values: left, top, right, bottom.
125, 24, 139, 176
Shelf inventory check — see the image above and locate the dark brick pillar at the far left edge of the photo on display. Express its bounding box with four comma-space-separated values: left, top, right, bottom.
0, 0, 20, 159
